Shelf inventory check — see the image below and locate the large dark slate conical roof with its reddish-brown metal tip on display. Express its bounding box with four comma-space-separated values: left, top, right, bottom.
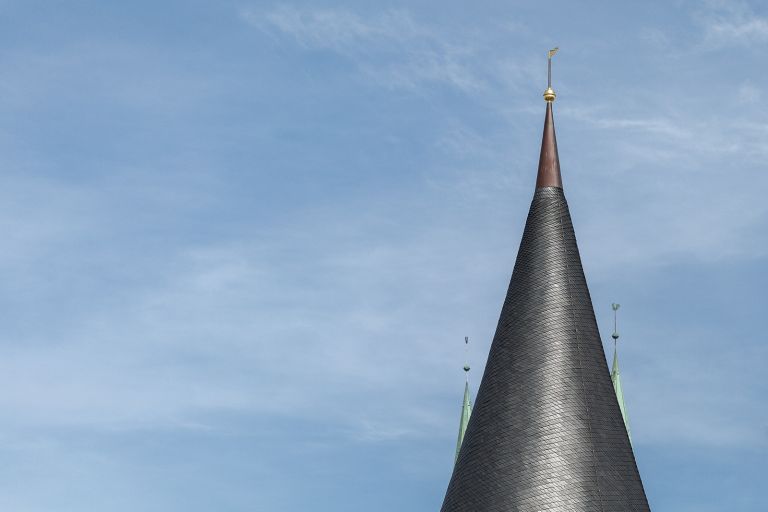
441, 102, 649, 512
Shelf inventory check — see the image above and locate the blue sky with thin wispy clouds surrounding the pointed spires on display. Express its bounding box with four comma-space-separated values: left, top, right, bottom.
0, 1, 768, 512
